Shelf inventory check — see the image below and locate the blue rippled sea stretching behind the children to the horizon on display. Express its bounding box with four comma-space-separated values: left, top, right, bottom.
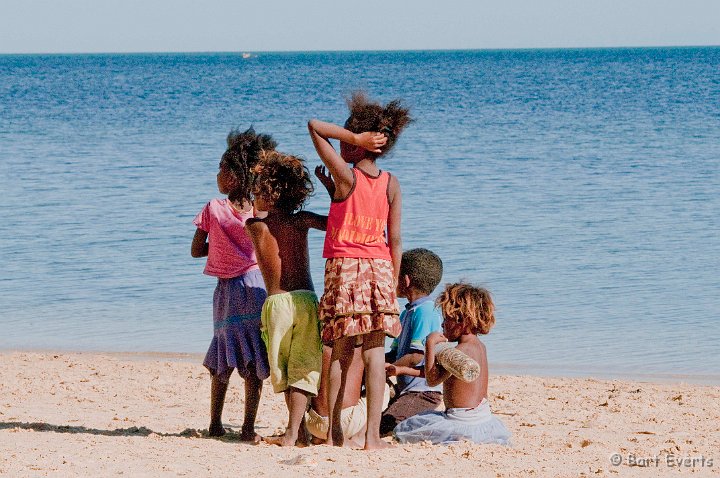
0, 48, 720, 383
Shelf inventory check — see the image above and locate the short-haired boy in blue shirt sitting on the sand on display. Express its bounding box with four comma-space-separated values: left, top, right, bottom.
380, 249, 443, 435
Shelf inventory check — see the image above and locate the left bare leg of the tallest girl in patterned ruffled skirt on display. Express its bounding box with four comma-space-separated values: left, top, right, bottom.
325, 337, 356, 446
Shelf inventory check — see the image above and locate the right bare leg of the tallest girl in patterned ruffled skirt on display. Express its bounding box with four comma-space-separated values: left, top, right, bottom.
363, 330, 390, 450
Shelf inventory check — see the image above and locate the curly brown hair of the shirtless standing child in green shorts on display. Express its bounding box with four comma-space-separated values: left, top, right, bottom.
252, 151, 314, 213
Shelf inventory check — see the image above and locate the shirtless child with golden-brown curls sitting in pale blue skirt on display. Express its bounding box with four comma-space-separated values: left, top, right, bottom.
394, 283, 510, 445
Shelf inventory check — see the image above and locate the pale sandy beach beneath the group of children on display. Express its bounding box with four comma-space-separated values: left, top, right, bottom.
0, 352, 720, 478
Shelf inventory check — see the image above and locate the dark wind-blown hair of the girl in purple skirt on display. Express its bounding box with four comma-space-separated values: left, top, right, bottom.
220, 126, 277, 202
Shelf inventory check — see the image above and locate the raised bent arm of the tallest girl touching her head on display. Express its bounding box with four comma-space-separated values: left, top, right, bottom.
308, 119, 387, 198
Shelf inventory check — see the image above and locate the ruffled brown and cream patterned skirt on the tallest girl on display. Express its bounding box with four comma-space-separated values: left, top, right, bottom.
320, 257, 401, 344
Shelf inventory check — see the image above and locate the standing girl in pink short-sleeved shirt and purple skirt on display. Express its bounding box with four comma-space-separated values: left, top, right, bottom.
190, 127, 276, 442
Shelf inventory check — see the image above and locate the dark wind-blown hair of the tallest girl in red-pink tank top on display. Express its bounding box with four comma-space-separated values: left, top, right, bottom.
345, 91, 412, 158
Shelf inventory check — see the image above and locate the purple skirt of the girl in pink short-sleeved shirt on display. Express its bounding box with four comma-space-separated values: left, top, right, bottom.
203, 269, 270, 382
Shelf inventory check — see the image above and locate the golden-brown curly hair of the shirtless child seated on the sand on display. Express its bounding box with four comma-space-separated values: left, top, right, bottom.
435, 282, 495, 334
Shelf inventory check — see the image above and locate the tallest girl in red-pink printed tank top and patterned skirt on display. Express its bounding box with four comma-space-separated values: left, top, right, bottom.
308, 93, 410, 449
